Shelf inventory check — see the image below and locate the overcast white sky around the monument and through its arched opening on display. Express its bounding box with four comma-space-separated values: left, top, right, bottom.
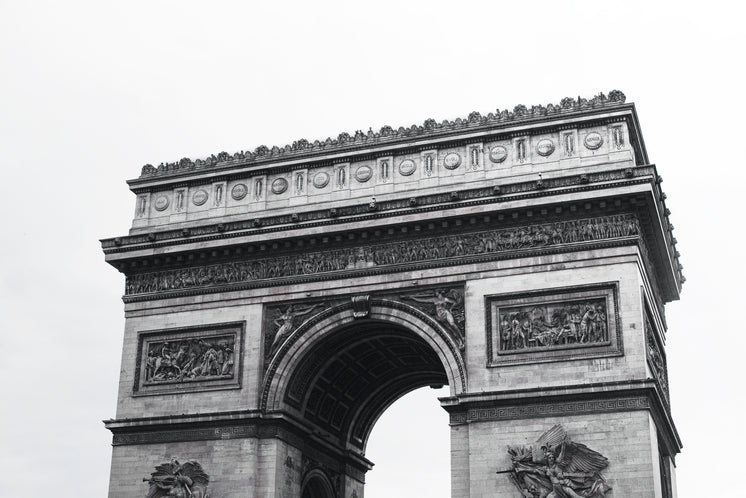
0, 0, 746, 498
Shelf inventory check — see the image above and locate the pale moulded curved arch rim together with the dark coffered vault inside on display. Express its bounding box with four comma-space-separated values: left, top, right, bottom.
262, 299, 467, 452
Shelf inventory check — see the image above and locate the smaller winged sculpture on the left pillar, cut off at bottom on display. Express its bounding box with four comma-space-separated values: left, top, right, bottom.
143, 458, 210, 498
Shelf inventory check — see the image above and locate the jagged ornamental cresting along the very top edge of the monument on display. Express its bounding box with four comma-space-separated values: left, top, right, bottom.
131, 90, 626, 183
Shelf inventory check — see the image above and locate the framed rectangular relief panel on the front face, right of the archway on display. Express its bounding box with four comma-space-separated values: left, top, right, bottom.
485, 284, 622, 366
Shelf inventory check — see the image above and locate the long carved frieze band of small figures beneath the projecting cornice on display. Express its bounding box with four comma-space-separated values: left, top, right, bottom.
125, 214, 640, 295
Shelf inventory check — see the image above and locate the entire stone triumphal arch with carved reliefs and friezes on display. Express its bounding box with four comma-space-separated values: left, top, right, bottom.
102, 91, 684, 498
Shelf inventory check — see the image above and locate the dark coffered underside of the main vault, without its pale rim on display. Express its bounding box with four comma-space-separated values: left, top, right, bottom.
285, 320, 448, 453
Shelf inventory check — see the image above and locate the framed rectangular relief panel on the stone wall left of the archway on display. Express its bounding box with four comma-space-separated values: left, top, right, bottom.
133, 322, 245, 395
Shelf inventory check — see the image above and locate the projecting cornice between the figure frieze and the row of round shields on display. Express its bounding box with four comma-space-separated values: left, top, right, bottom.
107, 165, 684, 301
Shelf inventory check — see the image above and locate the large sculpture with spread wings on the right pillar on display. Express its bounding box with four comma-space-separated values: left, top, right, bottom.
501, 424, 611, 498
